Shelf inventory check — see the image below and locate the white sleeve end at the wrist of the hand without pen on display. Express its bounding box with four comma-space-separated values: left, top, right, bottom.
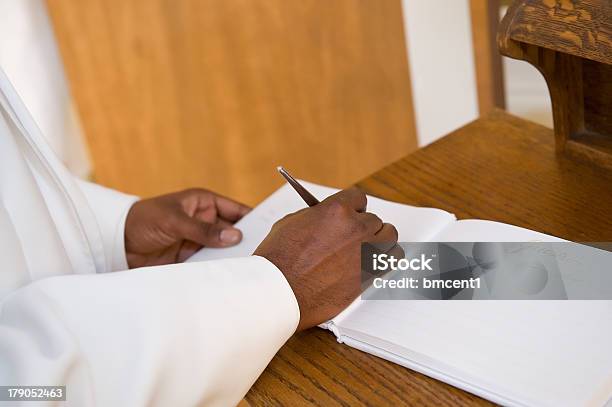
77, 179, 138, 271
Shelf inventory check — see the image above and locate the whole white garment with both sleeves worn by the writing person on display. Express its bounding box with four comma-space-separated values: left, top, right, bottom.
0, 70, 299, 407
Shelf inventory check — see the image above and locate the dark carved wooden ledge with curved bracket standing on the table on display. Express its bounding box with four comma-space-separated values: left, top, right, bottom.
498, 0, 612, 167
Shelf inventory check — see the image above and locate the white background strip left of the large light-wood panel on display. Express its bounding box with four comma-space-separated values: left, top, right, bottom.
0, 0, 90, 176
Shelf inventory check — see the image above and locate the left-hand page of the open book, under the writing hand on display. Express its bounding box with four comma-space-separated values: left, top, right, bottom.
187, 181, 455, 262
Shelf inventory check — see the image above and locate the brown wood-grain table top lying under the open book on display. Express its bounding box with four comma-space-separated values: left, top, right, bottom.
246, 111, 612, 406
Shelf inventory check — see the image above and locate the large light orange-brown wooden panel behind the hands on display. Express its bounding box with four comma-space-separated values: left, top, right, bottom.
47, 0, 416, 204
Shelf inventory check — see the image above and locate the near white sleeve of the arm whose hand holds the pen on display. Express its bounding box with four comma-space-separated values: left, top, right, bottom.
0, 256, 299, 406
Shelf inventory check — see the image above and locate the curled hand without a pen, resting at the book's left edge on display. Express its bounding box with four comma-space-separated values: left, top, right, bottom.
125, 189, 250, 268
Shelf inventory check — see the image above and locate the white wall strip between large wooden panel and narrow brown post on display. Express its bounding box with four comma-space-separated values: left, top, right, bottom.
402, 0, 478, 146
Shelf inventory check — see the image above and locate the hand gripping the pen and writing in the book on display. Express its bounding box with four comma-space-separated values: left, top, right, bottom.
254, 189, 397, 331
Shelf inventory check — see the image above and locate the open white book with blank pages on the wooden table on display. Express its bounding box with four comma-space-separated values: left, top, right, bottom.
189, 182, 612, 406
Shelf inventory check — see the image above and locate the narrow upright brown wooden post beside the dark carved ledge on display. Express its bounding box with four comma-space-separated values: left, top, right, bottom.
470, 0, 506, 115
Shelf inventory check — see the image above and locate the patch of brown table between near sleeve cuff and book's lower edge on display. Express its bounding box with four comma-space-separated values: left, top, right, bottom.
246, 329, 490, 407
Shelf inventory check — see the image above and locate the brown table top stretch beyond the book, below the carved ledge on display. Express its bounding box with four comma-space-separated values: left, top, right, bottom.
358, 110, 612, 242
